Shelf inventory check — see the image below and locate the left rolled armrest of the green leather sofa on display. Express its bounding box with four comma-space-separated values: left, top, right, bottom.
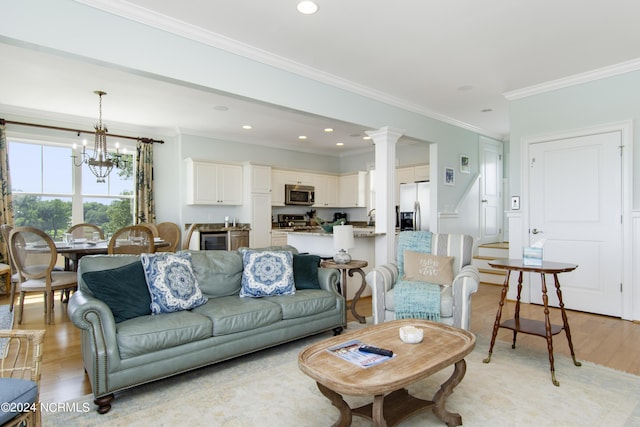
67, 290, 120, 378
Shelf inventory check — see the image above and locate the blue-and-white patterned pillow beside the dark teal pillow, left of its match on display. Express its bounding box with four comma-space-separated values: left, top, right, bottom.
140, 252, 207, 314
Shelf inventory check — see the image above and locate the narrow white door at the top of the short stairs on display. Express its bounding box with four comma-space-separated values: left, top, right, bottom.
479, 138, 503, 244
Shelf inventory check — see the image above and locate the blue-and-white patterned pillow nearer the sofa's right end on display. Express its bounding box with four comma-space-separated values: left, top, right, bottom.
240, 250, 296, 298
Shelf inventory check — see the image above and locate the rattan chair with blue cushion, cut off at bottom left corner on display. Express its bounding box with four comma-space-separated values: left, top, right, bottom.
0, 329, 45, 427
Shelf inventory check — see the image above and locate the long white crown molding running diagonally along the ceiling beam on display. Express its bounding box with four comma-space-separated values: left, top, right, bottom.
74, 0, 507, 140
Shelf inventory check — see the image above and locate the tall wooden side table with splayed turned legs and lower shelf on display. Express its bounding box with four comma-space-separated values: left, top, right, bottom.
483, 259, 582, 386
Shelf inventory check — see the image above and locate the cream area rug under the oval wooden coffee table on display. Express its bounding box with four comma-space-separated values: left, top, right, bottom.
43, 324, 640, 427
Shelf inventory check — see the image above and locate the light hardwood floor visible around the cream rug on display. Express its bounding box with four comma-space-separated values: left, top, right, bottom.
0, 284, 640, 403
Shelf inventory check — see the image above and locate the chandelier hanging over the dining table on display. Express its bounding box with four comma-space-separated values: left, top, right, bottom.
71, 90, 127, 183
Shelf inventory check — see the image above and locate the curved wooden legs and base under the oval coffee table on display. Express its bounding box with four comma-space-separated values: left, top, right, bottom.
316, 359, 467, 427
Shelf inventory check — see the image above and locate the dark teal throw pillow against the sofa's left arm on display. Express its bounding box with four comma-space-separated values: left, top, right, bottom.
82, 261, 151, 323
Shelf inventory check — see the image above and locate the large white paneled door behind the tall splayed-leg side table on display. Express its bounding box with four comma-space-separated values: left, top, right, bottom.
529, 132, 622, 316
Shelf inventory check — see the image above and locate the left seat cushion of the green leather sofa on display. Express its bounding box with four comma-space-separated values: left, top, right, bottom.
116, 311, 213, 359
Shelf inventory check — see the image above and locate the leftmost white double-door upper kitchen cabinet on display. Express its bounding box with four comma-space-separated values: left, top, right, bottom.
185, 158, 243, 205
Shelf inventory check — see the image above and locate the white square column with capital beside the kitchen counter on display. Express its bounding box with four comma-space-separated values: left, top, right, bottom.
366, 126, 403, 265
